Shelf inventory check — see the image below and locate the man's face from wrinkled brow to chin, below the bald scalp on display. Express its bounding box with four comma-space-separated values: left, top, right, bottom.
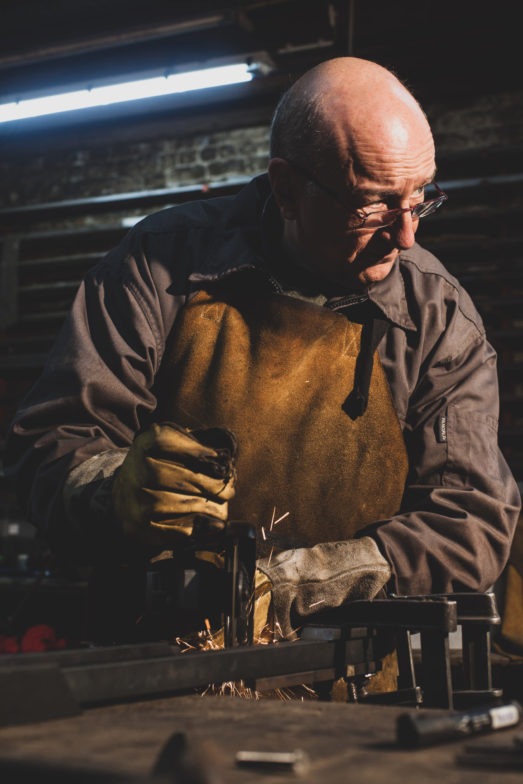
270, 132, 435, 290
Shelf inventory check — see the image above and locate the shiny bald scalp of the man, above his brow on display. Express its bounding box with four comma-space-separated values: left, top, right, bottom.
271, 57, 433, 184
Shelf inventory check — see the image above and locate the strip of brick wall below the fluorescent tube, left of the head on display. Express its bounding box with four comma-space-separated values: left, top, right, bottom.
0, 126, 269, 206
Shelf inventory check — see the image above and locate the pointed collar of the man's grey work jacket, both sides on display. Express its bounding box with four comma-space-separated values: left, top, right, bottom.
189, 174, 417, 331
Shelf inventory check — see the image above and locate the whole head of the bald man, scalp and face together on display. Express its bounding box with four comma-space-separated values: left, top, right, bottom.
269, 57, 435, 291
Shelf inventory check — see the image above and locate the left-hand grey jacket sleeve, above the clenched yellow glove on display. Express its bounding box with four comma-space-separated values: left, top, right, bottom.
6, 232, 181, 552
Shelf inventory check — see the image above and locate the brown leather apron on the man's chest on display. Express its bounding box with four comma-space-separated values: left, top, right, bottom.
155, 274, 408, 556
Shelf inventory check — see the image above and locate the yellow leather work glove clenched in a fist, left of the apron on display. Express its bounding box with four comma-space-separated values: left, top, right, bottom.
112, 422, 236, 547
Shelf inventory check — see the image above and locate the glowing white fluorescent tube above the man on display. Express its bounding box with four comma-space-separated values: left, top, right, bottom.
0, 63, 252, 123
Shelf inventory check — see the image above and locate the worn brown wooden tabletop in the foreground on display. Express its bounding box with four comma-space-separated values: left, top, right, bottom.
0, 695, 523, 784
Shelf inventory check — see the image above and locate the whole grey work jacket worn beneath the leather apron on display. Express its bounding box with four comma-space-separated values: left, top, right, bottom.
6, 176, 520, 593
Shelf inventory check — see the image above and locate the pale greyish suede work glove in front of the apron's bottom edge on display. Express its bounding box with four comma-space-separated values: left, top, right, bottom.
257, 536, 391, 639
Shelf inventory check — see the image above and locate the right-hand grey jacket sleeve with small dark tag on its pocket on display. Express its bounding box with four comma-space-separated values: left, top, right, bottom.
360, 281, 520, 594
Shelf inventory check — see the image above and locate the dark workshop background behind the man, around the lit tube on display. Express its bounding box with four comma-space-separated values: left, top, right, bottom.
0, 0, 523, 539
